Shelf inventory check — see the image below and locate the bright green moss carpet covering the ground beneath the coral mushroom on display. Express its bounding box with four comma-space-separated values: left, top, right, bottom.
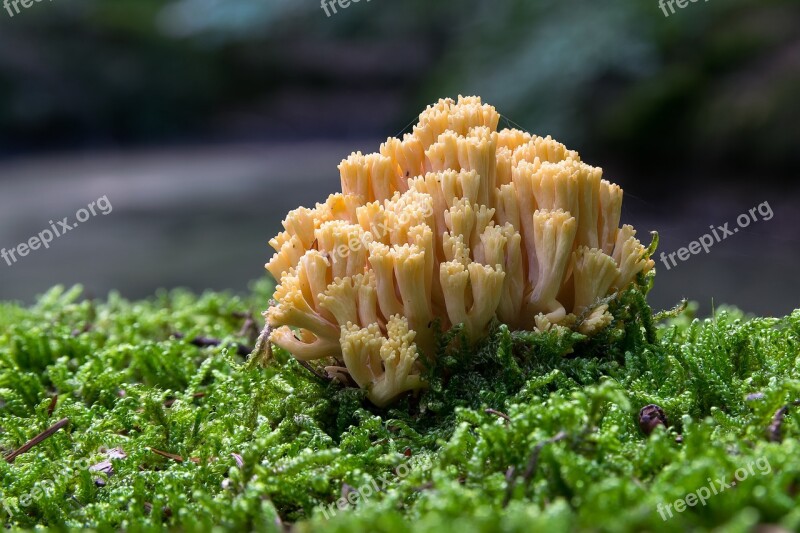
0, 283, 800, 532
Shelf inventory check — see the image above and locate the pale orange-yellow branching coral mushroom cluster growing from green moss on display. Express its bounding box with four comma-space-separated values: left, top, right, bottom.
266, 97, 654, 406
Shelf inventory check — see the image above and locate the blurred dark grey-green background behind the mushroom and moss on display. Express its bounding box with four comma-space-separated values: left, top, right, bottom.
0, 0, 800, 315
